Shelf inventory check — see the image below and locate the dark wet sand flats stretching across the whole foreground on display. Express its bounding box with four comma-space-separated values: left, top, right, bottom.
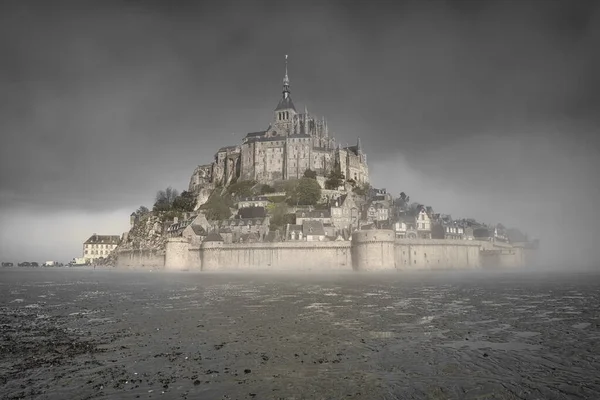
0, 268, 600, 400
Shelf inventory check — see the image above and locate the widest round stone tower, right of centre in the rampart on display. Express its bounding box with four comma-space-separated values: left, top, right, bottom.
352, 229, 396, 271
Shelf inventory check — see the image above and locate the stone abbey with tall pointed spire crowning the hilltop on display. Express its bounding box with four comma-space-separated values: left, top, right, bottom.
189, 56, 369, 199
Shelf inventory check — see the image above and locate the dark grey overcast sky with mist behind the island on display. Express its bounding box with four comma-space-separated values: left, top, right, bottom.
0, 0, 600, 267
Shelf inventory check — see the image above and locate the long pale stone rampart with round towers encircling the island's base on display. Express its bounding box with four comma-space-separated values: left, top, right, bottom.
117, 230, 535, 271
